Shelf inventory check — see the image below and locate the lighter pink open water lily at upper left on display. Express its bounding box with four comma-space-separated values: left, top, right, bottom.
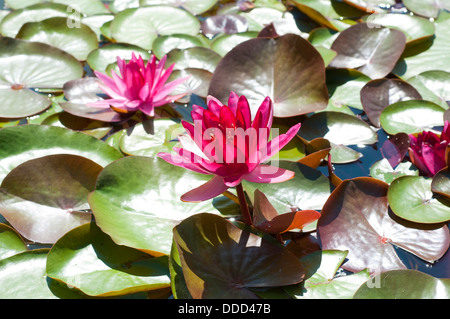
89, 53, 186, 116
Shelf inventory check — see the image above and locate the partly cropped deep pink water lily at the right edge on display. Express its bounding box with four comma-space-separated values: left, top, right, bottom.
409, 121, 450, 177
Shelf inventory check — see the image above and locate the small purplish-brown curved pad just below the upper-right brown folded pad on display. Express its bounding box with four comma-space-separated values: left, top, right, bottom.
360, 78, 422, 127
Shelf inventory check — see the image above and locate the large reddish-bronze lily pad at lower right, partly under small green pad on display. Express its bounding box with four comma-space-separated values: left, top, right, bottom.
317, 176, 450, 274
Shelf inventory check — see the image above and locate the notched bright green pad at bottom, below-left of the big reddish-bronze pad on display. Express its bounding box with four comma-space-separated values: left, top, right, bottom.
284, 250, 370, 299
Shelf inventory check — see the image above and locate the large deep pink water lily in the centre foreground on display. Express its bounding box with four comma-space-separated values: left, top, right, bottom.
158, 92, 300, 202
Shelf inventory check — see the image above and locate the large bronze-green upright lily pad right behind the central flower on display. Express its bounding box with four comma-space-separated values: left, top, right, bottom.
209, 34, 328, 117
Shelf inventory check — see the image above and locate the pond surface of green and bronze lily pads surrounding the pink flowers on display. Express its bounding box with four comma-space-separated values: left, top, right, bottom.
0, 0, 450, 299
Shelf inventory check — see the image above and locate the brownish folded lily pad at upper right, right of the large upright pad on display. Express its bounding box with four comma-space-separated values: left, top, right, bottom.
330, 23, 406, 79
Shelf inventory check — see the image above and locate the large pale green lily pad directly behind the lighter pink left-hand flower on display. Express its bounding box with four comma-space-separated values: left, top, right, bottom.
111, 5, 200, 50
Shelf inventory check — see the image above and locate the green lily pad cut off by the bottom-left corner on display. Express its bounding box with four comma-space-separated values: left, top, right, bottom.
0, 249, 57, 299
